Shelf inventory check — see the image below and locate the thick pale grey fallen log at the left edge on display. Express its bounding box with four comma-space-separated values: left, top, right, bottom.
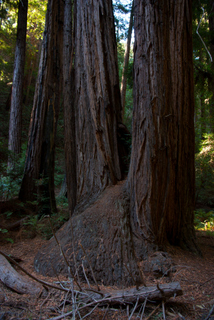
0, 254, 41, 294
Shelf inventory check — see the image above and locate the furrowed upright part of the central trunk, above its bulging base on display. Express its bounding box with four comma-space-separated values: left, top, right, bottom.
75, 0, 121, 210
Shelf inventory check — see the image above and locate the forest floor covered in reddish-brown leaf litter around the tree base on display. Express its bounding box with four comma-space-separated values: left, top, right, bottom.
0, 205, 214, 320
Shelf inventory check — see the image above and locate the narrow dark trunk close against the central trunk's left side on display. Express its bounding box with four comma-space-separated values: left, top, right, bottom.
63, 0, 77, 214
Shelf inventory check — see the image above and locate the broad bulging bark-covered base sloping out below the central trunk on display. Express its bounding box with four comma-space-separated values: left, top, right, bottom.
34, 182, 142, 286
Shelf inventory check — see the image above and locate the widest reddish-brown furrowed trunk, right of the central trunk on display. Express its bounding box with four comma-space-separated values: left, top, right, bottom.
129, 0, 195, 256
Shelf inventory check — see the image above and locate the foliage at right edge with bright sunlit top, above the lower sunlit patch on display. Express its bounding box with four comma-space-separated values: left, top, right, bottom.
195, 134, 214, 206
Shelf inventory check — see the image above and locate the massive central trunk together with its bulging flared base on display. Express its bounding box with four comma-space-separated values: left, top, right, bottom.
35, 0, 139, 284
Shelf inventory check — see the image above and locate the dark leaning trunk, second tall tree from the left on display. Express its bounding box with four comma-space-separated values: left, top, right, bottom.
19, 0, 64, 214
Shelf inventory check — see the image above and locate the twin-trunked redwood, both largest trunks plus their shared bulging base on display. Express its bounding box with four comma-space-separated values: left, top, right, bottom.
35, 0, 200, 284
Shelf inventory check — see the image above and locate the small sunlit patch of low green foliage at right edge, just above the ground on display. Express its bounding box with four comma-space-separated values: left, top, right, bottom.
194, 209, 214, 232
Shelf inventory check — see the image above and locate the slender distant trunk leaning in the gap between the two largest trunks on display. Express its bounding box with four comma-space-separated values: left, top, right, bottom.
120, 0, 134, 120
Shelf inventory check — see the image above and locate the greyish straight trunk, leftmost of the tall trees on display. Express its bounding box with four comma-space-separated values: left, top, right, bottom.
8, 0, 28, 167
